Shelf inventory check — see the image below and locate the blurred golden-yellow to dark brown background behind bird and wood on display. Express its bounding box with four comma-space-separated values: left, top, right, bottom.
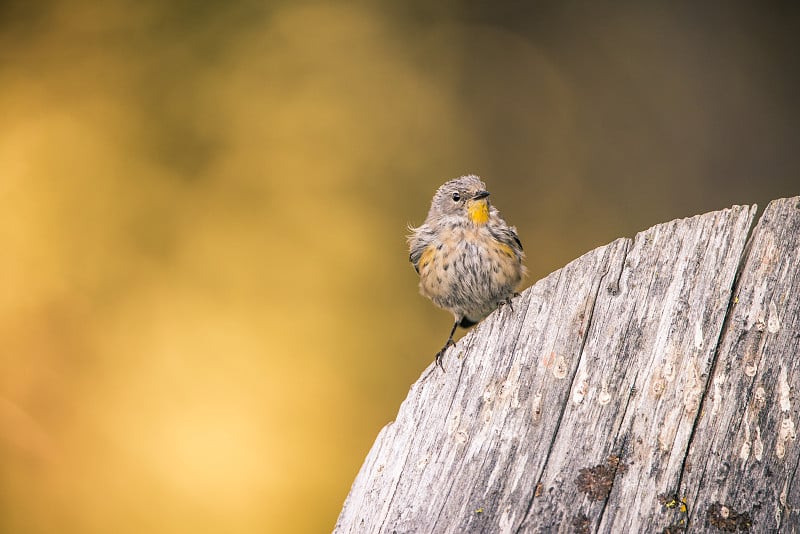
0, 0, 800, 534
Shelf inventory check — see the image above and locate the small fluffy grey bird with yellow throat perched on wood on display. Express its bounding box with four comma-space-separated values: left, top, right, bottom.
408, 178, 525, 371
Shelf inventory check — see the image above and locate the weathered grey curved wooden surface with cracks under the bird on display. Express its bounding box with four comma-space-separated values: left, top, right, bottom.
335, 197, 800, 533
